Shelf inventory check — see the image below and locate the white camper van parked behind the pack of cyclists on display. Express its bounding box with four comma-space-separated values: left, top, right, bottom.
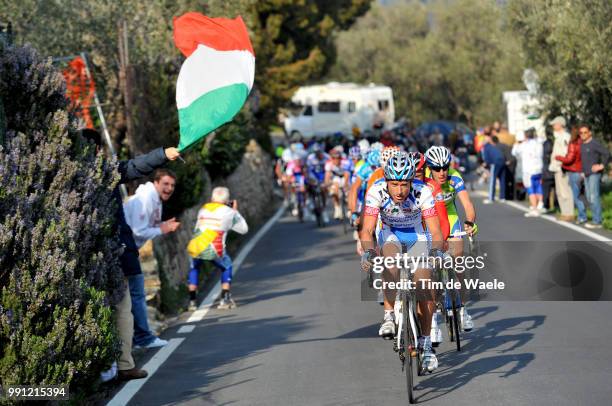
283, 82, 395, 138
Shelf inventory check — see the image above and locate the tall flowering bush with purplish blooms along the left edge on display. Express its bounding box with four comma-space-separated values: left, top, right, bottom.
0, 43, 123, 392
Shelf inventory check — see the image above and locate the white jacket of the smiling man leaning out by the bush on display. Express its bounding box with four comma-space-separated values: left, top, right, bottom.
123, 182, 162, 248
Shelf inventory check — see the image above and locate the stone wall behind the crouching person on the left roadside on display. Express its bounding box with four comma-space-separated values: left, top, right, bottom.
153, 140, 274, 313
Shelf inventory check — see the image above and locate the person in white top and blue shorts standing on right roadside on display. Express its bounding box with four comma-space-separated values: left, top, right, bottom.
512, 128, 544, 217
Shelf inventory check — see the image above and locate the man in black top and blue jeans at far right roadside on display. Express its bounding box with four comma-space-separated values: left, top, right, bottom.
579, 124, 610, 228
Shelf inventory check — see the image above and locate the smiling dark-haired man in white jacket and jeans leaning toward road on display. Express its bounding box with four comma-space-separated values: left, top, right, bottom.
123, 169, 180, 348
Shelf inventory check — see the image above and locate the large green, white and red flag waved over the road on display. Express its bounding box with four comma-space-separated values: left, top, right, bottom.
174, 12, 255, 151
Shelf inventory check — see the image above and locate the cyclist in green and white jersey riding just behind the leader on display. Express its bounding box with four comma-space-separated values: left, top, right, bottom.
425, 146, 478, 343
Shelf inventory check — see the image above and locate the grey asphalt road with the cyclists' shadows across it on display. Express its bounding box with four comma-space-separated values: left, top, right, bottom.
123, 193, 612, 406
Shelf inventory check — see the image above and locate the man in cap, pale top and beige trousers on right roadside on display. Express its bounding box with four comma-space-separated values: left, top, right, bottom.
548, 116, 574, 221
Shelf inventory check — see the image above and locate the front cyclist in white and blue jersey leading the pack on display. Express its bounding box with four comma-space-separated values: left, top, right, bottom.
359, 152, 444, 372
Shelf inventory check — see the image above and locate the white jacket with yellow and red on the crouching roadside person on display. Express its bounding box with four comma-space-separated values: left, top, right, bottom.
194, 203, 249, 252
